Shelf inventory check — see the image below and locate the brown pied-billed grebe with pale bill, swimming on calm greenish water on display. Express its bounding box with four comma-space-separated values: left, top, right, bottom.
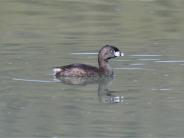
53, 45, 124, 77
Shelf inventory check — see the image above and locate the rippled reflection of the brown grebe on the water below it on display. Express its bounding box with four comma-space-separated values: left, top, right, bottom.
55, 76, 123, 104
